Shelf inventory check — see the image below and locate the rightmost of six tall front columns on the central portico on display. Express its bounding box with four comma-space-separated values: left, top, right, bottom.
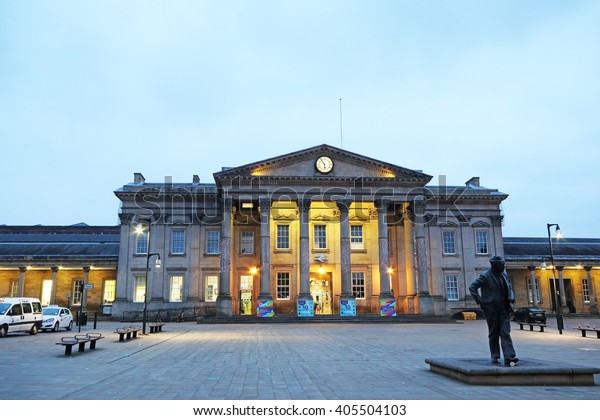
415, 199, 433, 315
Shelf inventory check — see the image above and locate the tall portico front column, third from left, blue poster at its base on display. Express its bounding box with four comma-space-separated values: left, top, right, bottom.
298, 199, 315, 316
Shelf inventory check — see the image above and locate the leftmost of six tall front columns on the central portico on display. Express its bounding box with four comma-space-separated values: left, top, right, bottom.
216, 197, 233, 316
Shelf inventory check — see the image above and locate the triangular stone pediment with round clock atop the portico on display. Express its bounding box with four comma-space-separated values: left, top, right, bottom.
214, 144, 431, 185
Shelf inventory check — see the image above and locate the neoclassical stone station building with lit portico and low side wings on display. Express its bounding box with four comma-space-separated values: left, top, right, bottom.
0, 145, 600, 317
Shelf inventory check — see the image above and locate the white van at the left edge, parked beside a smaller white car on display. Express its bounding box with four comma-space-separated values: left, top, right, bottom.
0, 298, 42, 337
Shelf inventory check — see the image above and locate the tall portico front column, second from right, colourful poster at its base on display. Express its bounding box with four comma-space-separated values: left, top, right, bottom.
375, 200, 396, 316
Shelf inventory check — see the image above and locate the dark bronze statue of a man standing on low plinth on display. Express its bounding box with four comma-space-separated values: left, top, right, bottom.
469, 256, 519, 366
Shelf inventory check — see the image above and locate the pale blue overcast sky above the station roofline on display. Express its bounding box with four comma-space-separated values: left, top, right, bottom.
0, 0, 600, 238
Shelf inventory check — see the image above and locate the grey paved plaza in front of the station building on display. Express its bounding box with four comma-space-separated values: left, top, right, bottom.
0, 318, 600, 400
